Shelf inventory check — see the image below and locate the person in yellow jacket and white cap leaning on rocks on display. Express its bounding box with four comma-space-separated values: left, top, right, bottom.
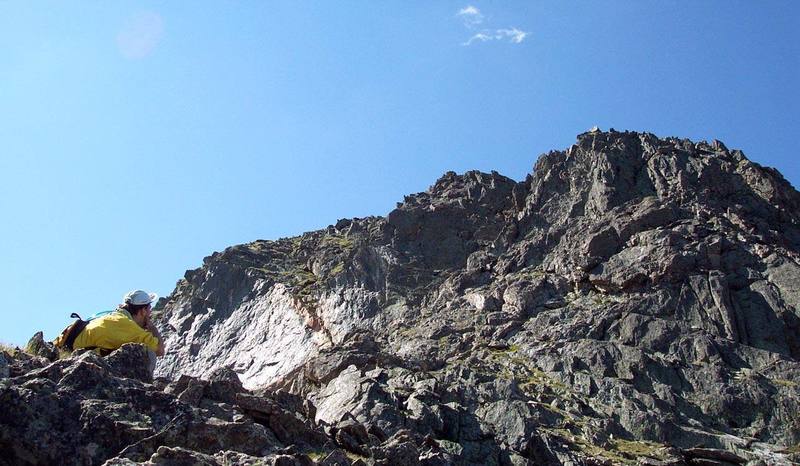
72, 290, 164, 358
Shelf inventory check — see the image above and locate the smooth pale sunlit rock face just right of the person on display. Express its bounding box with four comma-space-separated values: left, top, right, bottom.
156, 281, 378, 389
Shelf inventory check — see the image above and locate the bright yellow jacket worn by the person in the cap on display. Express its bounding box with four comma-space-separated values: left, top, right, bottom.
72, 309, 158, 351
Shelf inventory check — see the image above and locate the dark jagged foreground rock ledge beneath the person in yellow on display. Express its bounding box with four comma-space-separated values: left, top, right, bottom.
0, 344, 333, 465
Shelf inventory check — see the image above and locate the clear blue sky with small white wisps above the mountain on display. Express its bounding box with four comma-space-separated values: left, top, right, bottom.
0, 0, 800, 344
